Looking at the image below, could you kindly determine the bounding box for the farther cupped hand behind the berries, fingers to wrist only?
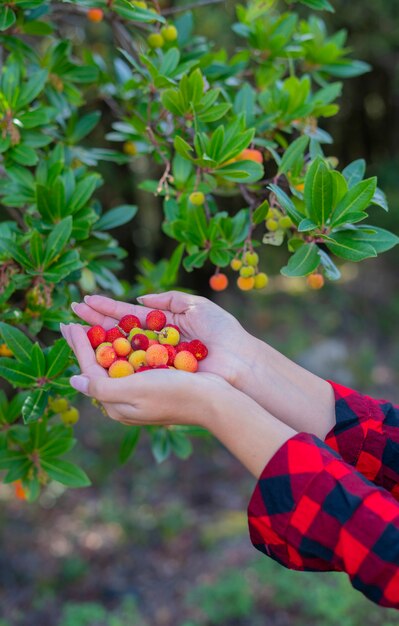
[69,291,254,386]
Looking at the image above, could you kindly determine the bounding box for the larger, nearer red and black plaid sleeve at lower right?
[248,433,399,609]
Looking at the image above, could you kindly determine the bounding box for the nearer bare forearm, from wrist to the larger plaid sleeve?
[203,382,296,478]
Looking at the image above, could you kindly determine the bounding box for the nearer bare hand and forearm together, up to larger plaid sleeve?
[63,324,296,478]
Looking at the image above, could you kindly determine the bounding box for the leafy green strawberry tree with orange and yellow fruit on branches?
[0,0,398,500]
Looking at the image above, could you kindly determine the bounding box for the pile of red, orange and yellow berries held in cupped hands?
[87,311,208,378]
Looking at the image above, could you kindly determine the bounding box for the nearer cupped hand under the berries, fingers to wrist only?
[62,324,229,427]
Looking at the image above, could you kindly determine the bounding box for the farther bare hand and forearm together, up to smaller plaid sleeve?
[68,291,335,439]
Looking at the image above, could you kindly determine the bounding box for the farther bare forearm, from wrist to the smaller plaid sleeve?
[235,334,335,439]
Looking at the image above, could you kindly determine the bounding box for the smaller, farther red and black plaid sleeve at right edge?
[325,381,399,500]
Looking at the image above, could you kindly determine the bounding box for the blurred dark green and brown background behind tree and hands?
[0,0,399,626]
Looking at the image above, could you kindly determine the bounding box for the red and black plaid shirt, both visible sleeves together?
[248,381,399,609]
